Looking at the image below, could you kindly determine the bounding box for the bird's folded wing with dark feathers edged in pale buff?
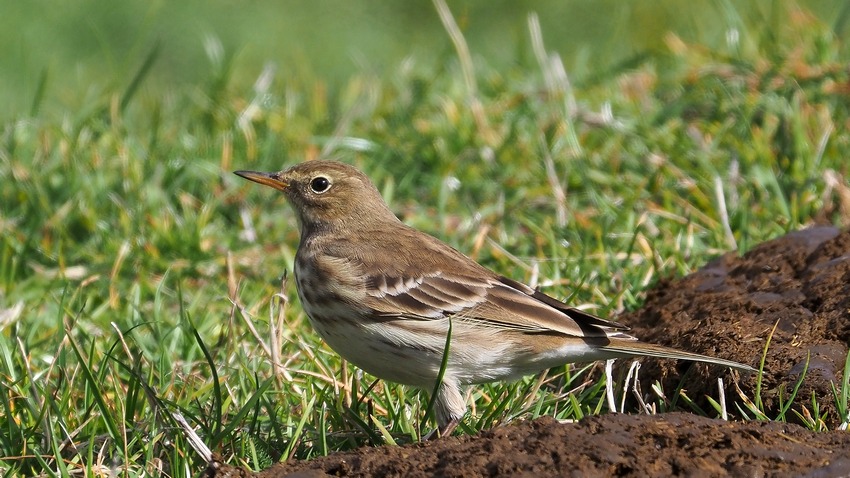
[363,271,631,339]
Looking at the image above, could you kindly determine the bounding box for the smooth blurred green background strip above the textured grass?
[0,0,848,120]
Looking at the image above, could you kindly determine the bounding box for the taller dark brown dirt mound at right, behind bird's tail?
[619,227,850,428]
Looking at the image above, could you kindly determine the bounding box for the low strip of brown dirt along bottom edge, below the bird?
[210,413,850,478]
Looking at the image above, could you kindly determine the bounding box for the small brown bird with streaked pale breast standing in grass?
[235,160,753,436]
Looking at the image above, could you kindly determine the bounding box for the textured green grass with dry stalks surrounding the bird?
[0,0,850,476]
